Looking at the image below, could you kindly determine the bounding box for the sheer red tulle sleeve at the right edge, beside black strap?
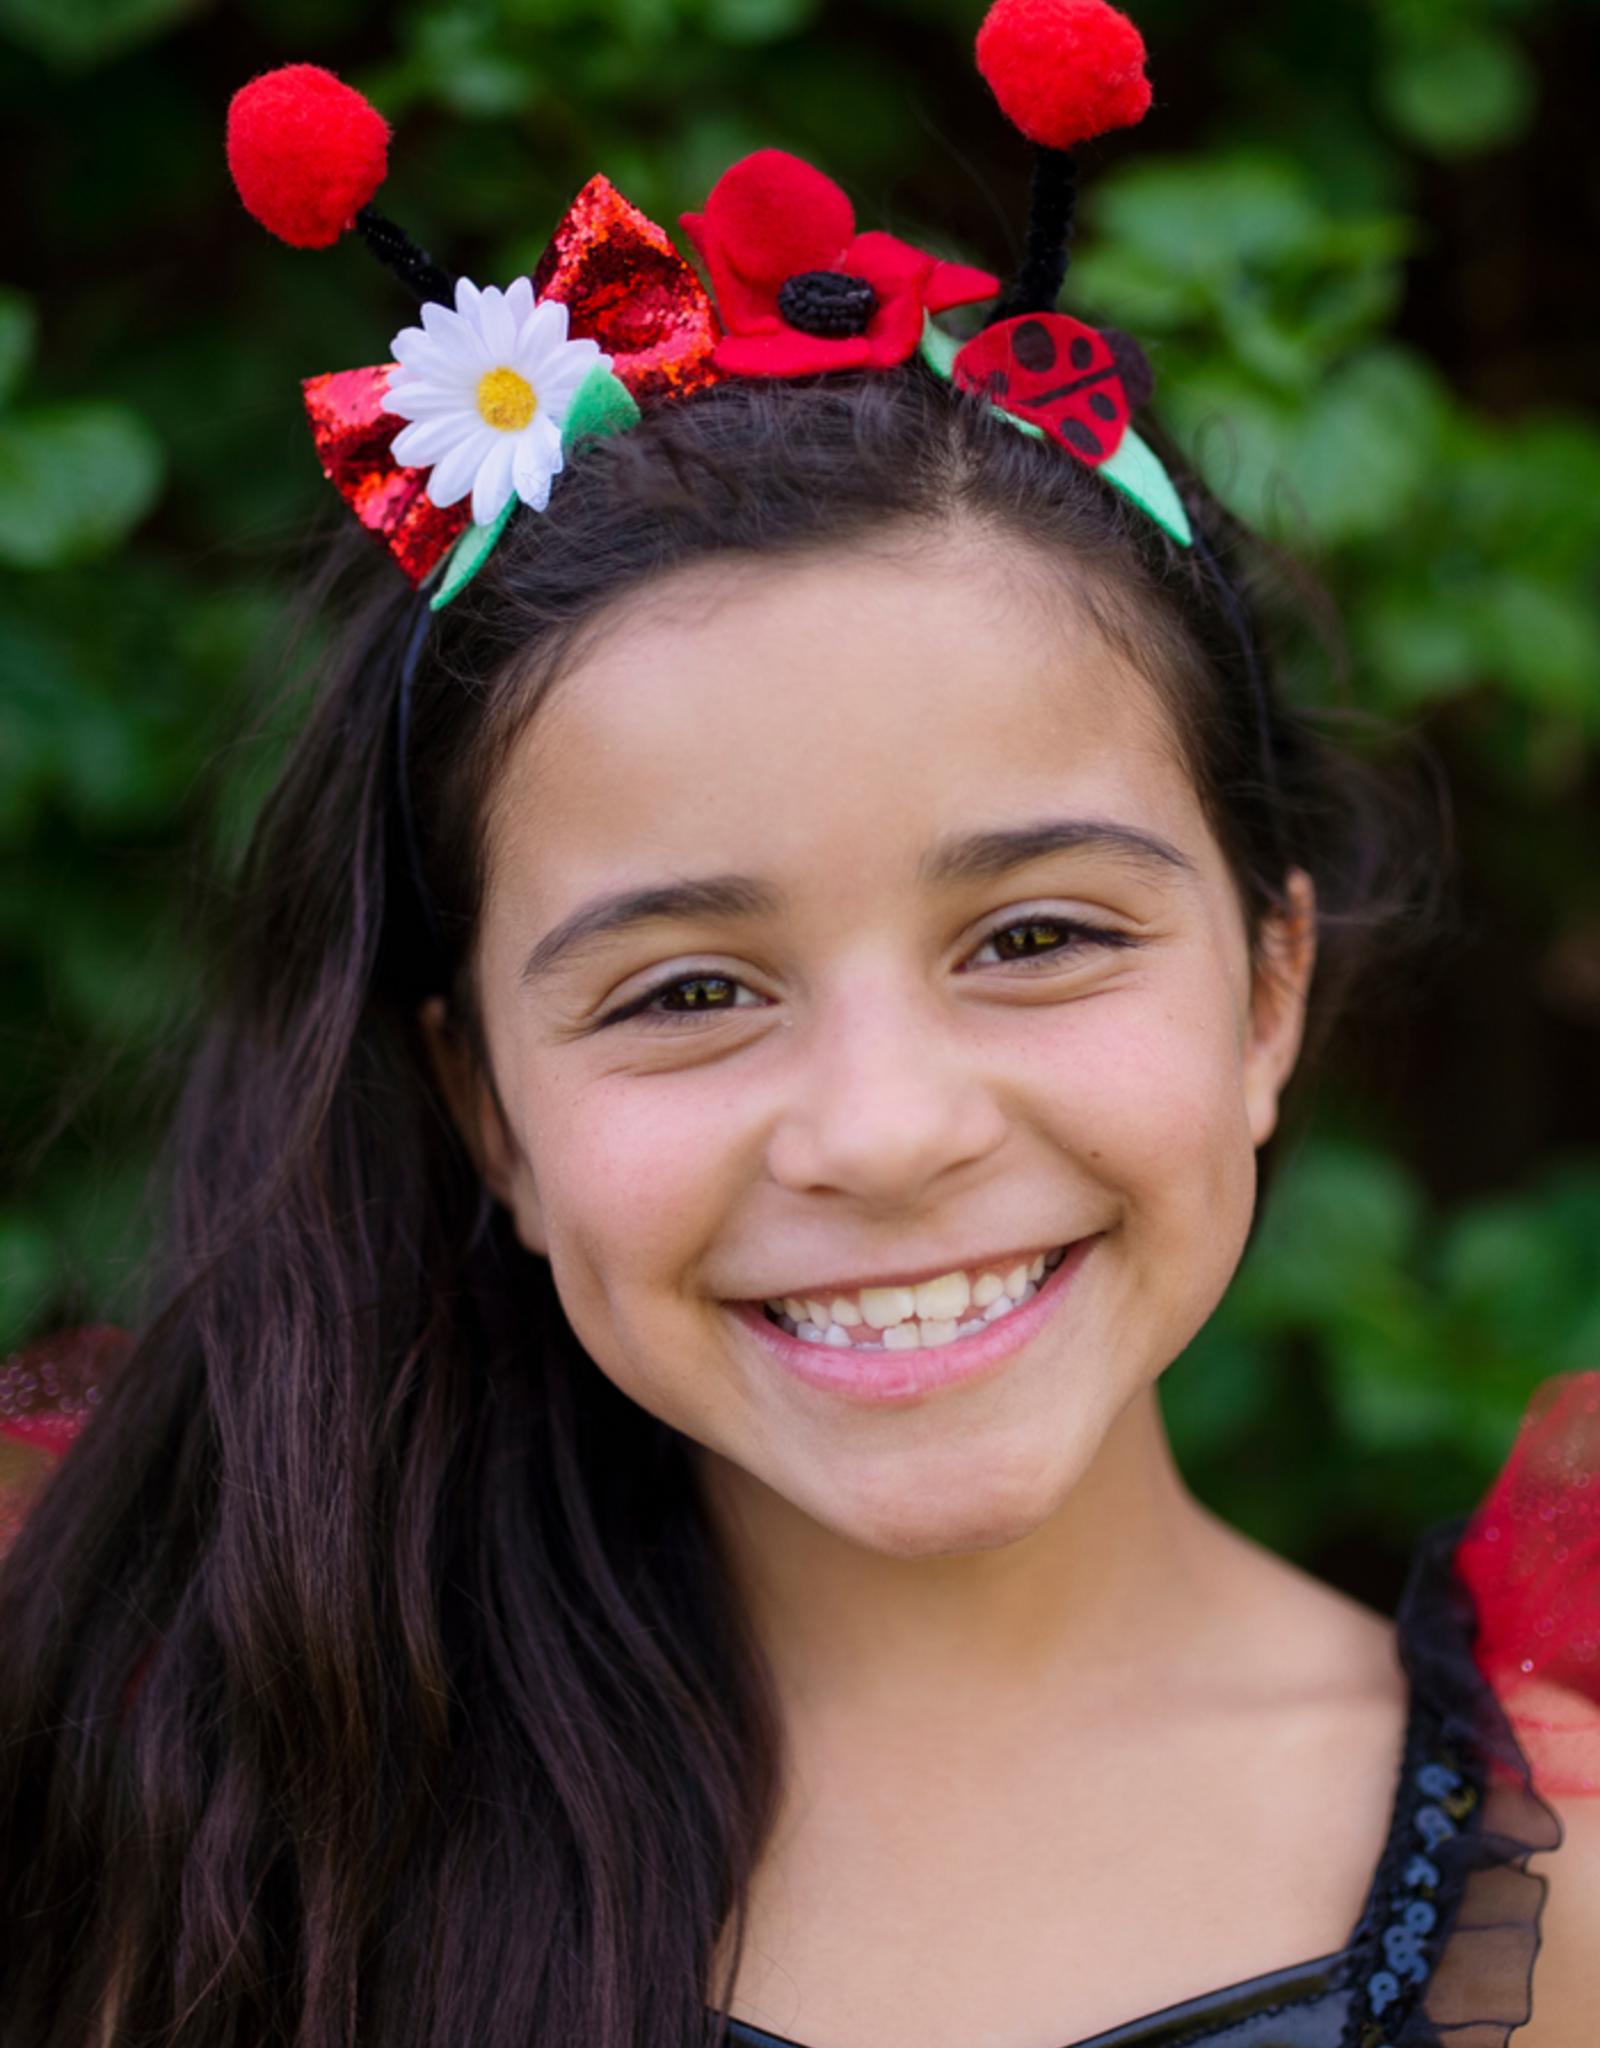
[1457,1372,1600,1798]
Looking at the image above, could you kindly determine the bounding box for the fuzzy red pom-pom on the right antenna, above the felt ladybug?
[977,0,1149,150]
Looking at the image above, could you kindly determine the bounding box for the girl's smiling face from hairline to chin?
[442,532,1309,1556]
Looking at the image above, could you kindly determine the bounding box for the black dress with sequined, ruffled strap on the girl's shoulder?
[727,1528,1559,2048]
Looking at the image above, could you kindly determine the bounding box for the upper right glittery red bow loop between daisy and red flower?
[533,178,721,406]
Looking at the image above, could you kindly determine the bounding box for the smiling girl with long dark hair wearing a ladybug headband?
[0,8,1600,2048]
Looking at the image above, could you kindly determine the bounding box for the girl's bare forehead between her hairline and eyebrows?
[488,535,1203,895]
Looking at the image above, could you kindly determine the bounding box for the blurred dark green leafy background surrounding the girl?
[0,0,1600,1583]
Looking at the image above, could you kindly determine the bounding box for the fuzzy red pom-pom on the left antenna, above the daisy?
[227,63,389,250]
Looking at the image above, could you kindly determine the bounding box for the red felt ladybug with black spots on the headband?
[953,313,1151,469]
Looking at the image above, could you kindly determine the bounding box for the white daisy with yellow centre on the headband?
[383,276,610,526]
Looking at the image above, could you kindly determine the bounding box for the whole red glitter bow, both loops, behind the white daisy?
[305,178,719,584]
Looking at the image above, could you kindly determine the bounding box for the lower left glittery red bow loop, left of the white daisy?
[305,362,471,584]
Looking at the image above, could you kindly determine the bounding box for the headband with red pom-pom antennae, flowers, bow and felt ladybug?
[227,0,1192,610]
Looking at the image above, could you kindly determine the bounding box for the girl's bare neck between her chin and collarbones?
[705,1391,1231,1712]
